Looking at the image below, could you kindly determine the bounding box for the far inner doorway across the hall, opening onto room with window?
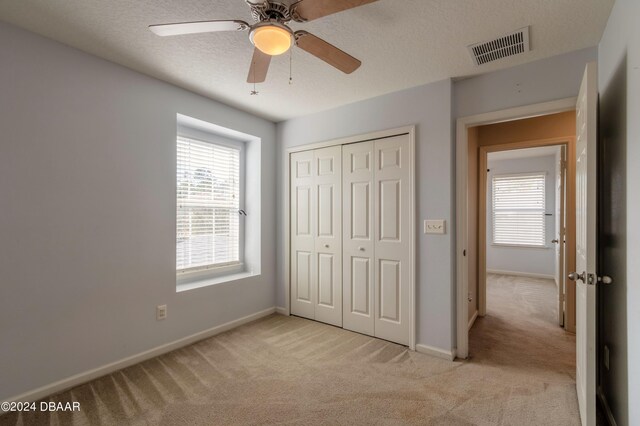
[478,144,567,328]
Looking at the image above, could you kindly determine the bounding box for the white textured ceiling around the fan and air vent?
[0,0,614,121]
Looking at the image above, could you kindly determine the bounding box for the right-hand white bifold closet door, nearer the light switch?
[342,135,413,345]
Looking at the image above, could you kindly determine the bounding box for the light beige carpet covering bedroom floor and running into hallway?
[0,277,579,426]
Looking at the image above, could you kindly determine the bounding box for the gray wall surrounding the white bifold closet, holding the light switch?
[277,80,455,350]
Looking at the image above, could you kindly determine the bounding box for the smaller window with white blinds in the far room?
[492,173,546,247]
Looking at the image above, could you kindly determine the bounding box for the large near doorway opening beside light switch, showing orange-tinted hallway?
[466,111,576,394]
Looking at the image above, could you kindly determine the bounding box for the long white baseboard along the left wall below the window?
[6,307,276,402]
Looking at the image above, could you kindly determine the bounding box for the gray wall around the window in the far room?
[486,154,557,278]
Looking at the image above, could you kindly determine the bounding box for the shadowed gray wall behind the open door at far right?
[598,0,640,425]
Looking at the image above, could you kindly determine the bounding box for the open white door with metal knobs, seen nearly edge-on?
[571,63,598,426]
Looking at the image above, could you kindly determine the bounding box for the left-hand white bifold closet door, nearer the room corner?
[290,146,342,326]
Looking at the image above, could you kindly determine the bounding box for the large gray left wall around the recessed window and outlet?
[0,23,276,400]
